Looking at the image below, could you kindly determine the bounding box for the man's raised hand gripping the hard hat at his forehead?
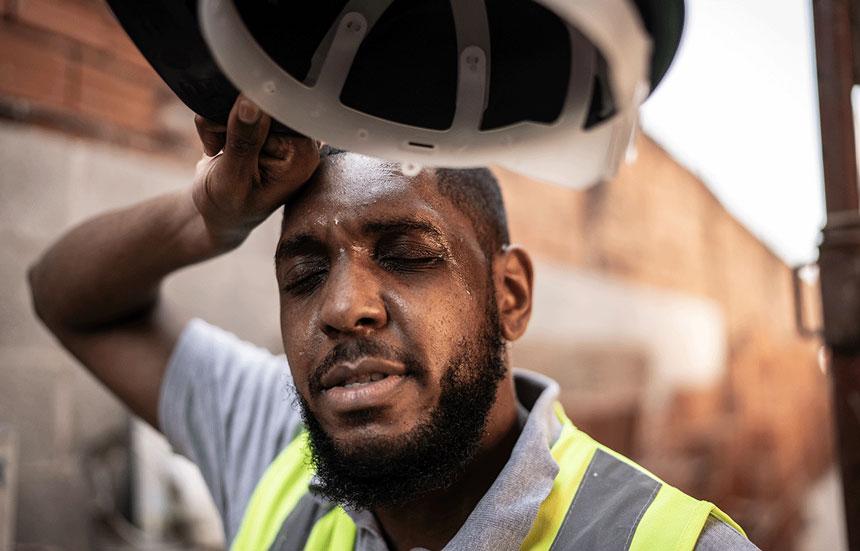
[192,95,319,248]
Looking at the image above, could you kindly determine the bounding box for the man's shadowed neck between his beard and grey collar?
[374,376,521,551]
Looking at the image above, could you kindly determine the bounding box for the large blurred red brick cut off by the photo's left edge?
[0,22,69,109]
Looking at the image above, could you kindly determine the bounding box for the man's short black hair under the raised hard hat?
[320,145,511,259]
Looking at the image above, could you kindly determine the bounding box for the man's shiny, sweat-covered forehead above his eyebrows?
[282,153,466,242]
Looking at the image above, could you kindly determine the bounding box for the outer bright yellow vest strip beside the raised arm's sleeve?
[230,432,313,551]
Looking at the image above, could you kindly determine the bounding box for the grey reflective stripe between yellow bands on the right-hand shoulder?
[551,449,662,551]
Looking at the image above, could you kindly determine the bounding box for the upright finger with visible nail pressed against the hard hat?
[223,95,270,178]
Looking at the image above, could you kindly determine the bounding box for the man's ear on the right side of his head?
[493,245,534,341]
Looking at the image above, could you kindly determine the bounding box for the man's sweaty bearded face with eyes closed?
[276,154,504,506]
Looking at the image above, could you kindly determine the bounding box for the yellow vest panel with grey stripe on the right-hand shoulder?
[521,404,743,551]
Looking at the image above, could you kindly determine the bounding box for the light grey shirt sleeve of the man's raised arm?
[158,319,301,541]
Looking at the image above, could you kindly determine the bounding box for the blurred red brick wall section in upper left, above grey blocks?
[0,0,197,160]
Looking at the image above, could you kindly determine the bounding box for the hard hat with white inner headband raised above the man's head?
[110,0,684,187]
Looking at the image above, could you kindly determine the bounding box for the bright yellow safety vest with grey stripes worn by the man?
[231,403,744,551]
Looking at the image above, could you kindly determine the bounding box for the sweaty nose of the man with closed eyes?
[320,260,388,338]
